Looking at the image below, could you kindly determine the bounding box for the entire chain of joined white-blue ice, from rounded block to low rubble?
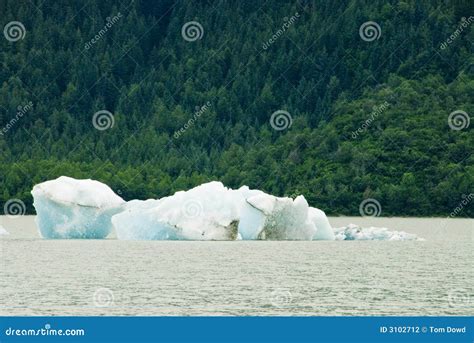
[30,176,420,241]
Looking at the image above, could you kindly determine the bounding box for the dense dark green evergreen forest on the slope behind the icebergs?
[0,0,474,216]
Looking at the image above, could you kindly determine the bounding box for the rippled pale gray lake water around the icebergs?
[0,216,474,316]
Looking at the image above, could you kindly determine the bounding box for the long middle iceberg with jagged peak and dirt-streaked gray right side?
[112,181,334,240]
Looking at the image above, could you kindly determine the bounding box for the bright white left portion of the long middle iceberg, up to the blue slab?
[112,182,243,240]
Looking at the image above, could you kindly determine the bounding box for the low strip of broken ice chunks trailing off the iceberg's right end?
[334,224,423,241]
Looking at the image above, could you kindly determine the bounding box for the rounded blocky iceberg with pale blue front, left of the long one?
[31,176,125,239]
